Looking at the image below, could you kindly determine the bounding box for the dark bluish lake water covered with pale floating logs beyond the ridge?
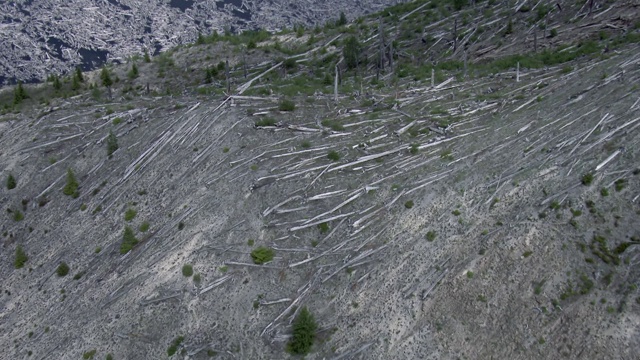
[0,0,395,85]
